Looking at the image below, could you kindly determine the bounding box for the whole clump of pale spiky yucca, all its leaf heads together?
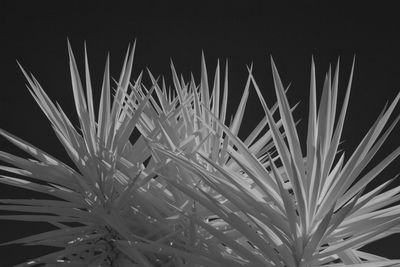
[0,42,400,266]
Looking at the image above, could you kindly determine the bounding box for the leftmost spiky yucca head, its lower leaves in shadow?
[0,44,222,266]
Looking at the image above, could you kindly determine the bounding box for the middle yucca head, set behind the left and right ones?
[138,55,288,218]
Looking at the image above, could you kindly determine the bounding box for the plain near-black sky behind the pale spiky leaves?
[0,1,400,266]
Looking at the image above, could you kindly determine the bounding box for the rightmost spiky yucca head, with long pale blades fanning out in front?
[154,58,400,266]
